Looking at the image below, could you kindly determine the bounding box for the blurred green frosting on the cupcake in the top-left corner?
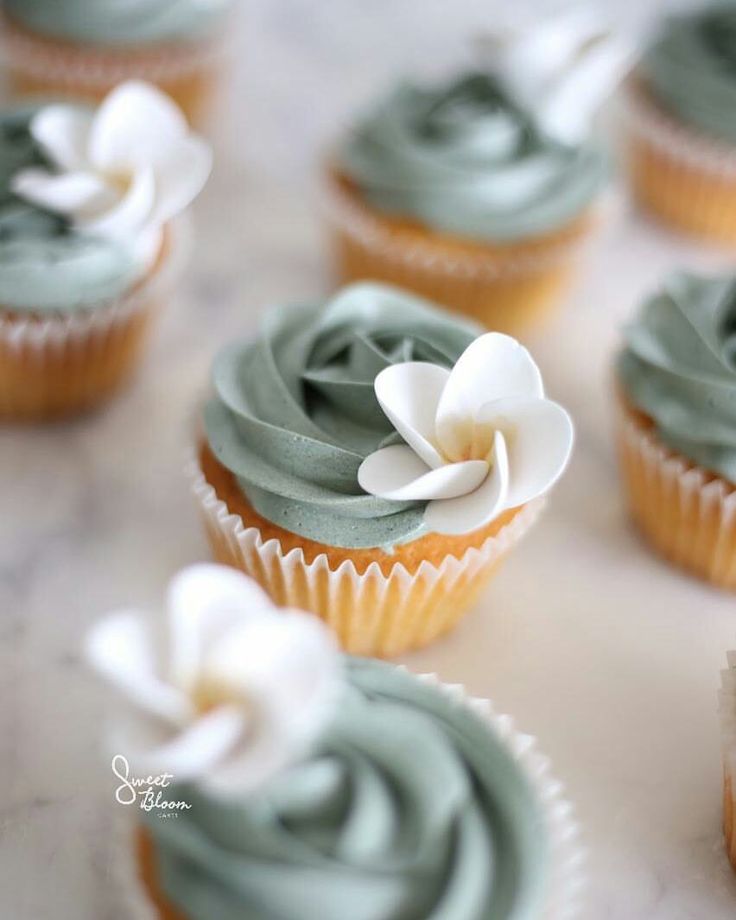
[3,0,233,45]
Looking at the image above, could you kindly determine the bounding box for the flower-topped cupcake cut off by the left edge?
[0,83,211,420]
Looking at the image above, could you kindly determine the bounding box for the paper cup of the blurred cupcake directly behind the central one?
[323,177,600,335]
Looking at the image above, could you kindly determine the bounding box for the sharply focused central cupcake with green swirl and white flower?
[192,283,572,657]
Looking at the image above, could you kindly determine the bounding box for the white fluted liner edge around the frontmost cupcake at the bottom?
[113,667,586,920]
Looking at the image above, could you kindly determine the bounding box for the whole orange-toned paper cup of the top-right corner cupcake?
[625,83,736,246]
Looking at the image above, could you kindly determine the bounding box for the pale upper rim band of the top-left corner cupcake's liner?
[0,13,225,87]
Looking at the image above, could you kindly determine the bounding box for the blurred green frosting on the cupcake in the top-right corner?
[641,2,736,143]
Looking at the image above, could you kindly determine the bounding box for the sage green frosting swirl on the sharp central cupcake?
[205,283,481,550]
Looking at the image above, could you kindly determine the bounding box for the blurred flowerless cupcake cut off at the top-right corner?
[628,2,736,245]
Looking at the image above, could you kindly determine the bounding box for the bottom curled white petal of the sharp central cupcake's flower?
[424,432,509,534]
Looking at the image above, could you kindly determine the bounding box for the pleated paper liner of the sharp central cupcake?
[187,459,544,658]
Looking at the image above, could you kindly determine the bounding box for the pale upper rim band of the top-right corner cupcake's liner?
[623,80,736,180]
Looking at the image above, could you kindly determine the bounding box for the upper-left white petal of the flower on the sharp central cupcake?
[373,361,450,469]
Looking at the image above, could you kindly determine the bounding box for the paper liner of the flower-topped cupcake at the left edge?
[0,219,190,421]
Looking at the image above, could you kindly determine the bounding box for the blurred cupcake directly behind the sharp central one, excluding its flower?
[327,72,606,334]
